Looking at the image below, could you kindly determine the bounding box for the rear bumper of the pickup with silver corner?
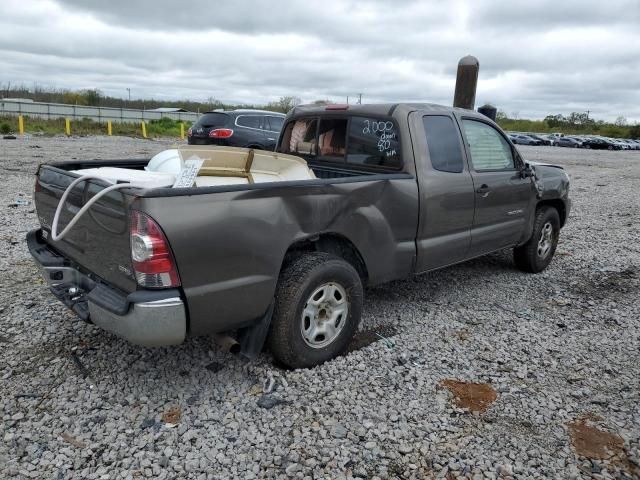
[27,230,187,347]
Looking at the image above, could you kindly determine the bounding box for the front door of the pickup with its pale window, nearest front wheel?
[462,117,534,257]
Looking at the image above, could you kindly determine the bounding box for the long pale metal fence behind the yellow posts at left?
[0,100,199,123]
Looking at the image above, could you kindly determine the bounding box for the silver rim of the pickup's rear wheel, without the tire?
[300,282,349,348]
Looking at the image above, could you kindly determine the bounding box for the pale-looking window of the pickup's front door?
[462,120,515,172]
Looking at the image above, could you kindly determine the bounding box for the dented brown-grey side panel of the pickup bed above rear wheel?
[140,174,418,335]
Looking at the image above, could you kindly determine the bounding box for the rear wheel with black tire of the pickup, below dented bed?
[267,252,363,368]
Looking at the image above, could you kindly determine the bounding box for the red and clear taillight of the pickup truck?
[131,210,180,288]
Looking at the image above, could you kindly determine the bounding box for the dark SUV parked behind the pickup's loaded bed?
[187,110,285,150]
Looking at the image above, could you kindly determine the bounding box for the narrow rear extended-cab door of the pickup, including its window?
[410,112,475,272]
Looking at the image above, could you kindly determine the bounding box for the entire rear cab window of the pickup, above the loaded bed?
[277,116,402,170]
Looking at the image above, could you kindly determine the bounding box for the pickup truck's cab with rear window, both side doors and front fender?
[276,104,569,273]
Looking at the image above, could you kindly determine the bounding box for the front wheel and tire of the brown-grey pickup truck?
[513,206,560,273]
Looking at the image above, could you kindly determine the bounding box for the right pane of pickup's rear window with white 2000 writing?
[347,117,402,169]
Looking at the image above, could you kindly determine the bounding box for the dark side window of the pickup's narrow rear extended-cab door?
[422,115,463,173]
